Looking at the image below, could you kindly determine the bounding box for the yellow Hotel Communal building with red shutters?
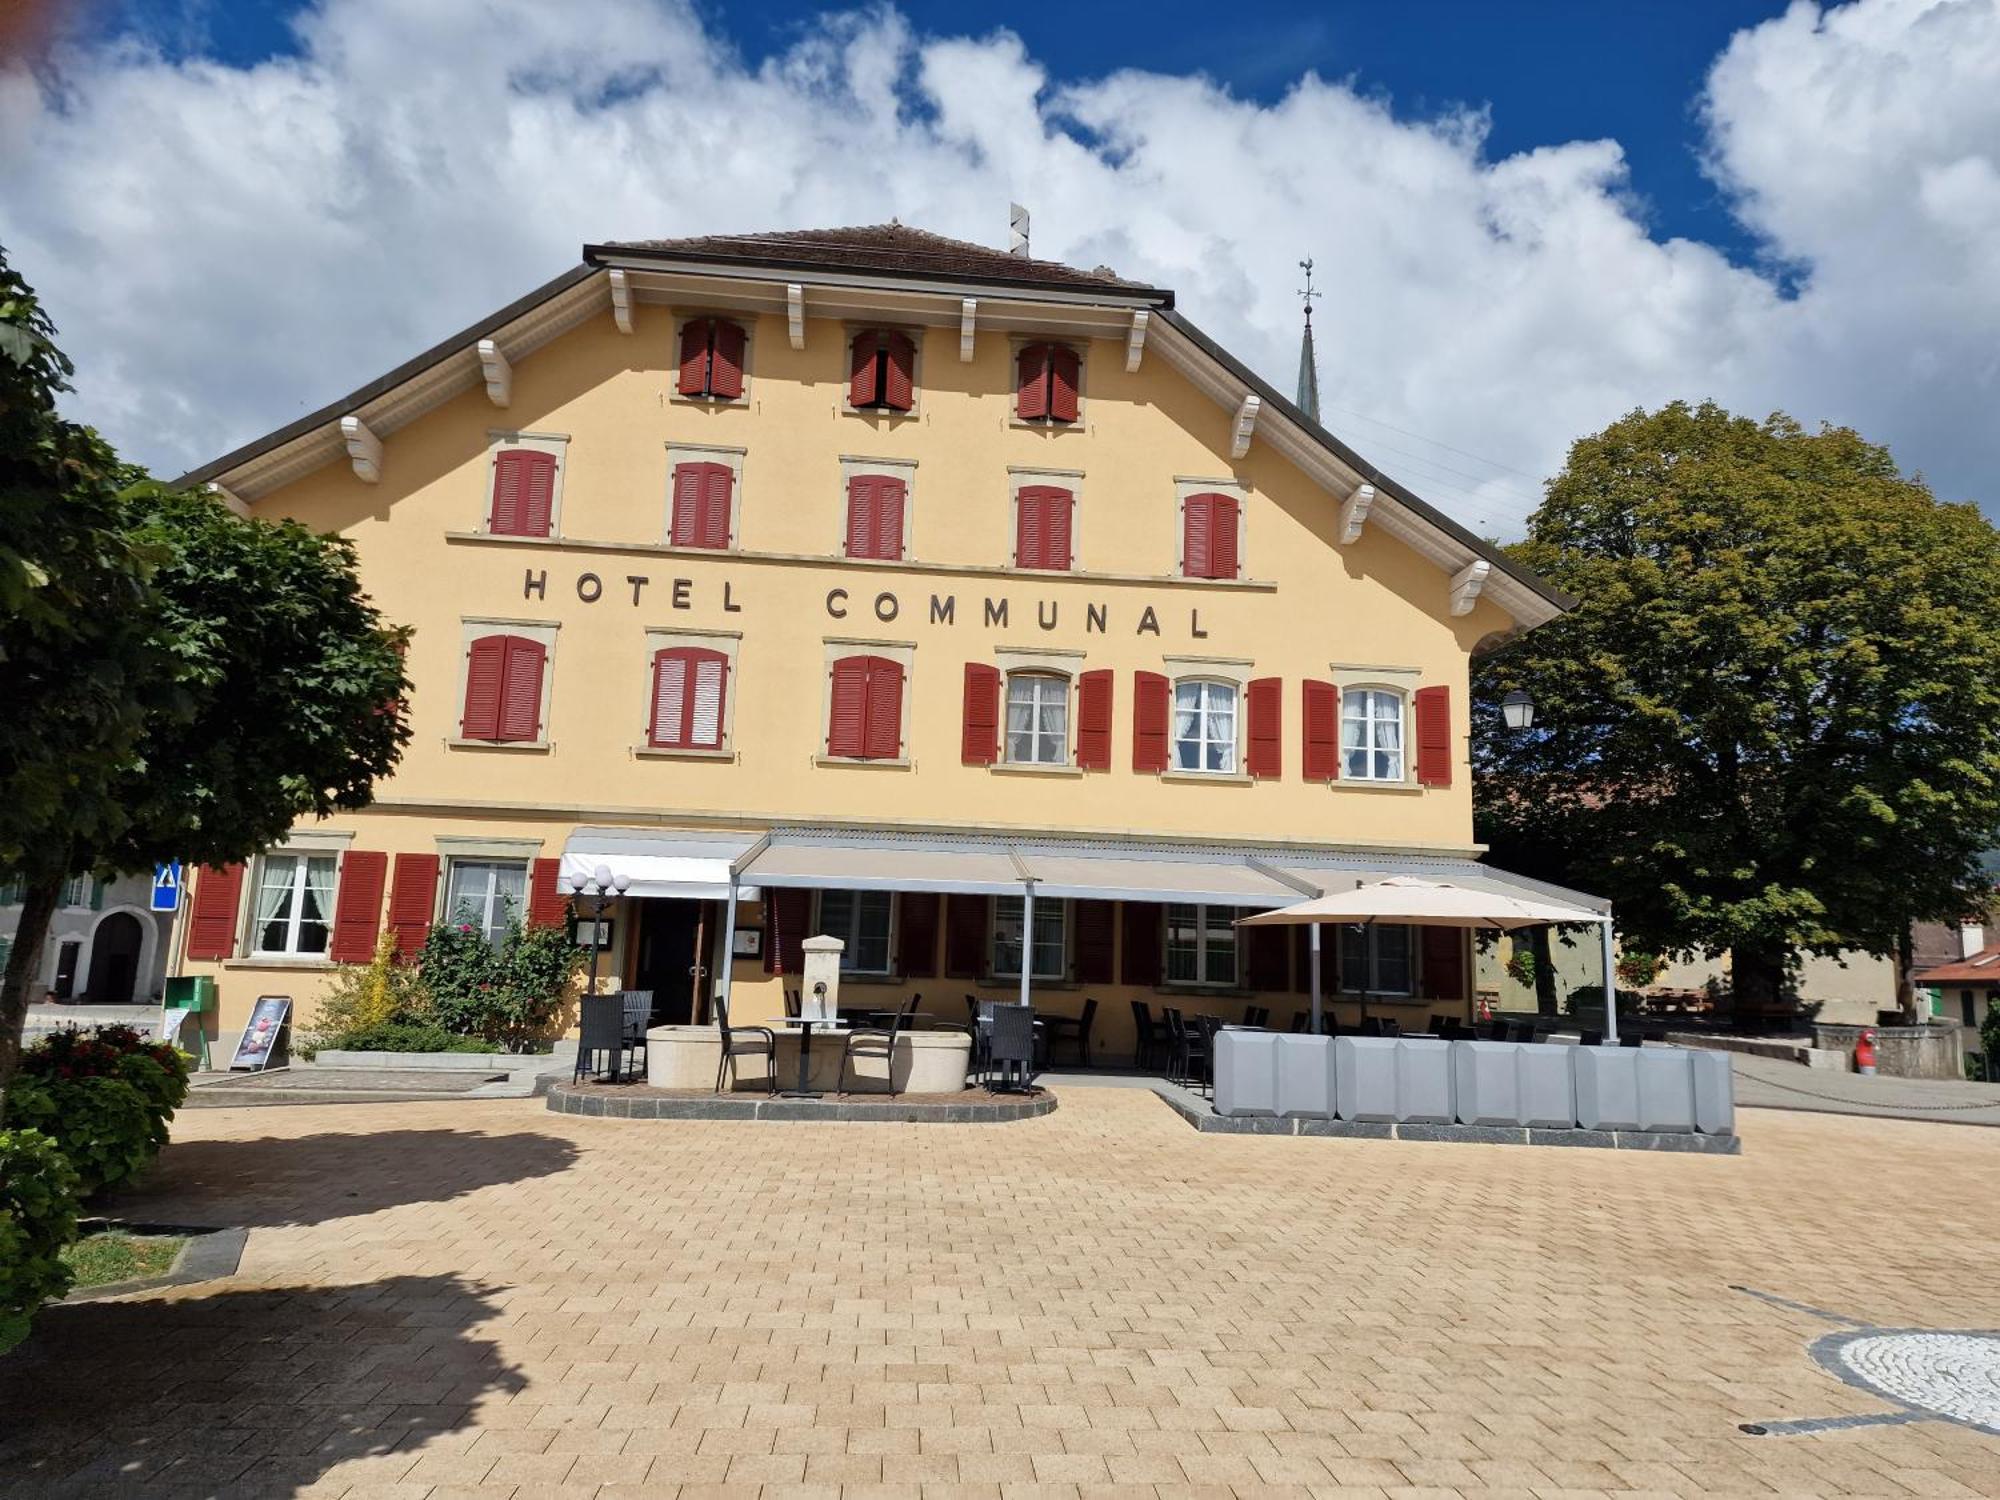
[184,226,1600,1060]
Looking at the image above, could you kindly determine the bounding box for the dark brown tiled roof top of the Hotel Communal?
[590,224,1154,292]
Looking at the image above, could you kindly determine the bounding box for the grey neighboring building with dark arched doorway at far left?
[0,874,174,1006]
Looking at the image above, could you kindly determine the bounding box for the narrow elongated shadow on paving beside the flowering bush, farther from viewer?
[92,1130,576,1228]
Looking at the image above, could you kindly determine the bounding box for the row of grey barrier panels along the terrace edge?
[1214,1028,1736,1136]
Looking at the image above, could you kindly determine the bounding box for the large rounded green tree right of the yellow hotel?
[1474,402,2000,1012]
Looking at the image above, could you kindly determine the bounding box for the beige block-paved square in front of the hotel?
[0,1088,2000,1500]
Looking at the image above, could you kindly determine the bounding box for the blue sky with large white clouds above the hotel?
[0,0,2000,538]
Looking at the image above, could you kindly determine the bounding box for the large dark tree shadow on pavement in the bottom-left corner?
[0,1276,526,1500]
